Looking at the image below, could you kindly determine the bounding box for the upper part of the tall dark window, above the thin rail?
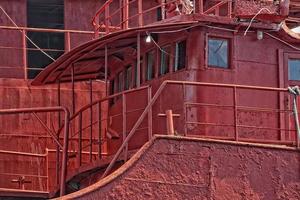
[27,0,64,29]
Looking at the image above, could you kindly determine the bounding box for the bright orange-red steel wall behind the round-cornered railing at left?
[0,79,104,191]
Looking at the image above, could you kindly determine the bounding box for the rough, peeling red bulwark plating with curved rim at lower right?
[63,138,300,200]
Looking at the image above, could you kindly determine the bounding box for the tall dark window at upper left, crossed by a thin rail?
[27,0,65,79]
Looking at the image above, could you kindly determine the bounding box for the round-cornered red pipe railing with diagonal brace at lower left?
[0,106,70,196]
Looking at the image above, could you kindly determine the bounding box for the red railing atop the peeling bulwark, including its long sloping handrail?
[102,80,299,177]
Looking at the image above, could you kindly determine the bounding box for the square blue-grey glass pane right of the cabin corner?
[208,38,229,68]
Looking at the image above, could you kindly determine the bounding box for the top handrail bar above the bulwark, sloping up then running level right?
[101,80,290,178]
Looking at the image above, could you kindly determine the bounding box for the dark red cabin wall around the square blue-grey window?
[109,26,300,151]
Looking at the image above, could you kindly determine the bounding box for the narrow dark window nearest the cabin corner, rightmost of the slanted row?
[174,40,186,71]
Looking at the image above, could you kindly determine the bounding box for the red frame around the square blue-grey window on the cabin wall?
[204,33,235,71]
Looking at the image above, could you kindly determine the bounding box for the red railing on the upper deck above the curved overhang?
[92,0,232,37]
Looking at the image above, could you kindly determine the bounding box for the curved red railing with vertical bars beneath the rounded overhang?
[65,86,151,167]
